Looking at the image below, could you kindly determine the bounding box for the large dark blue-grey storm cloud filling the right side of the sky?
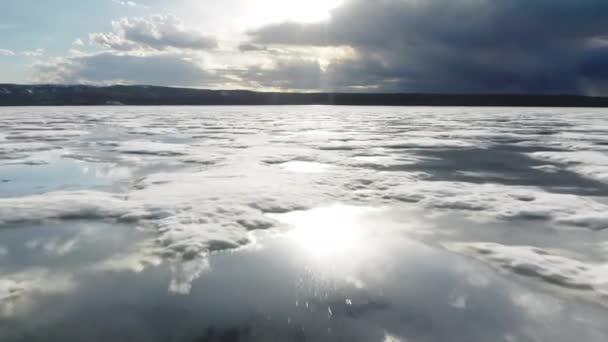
[249,0,608,93]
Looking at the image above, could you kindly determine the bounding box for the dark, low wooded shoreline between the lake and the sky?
[0,84,608,108]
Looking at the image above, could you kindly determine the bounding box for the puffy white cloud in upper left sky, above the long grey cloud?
[89,15,218,51]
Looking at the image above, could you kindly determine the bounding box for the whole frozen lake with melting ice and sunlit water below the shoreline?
[0,106,608,342]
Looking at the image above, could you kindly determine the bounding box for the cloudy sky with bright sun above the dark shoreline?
[0,0,608,96]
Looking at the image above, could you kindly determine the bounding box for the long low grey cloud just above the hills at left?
[36,53,221,86]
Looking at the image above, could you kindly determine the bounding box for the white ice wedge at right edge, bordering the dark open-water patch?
[529,151,608,183]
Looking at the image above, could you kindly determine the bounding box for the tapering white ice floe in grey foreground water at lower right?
[445,242,608,299]
